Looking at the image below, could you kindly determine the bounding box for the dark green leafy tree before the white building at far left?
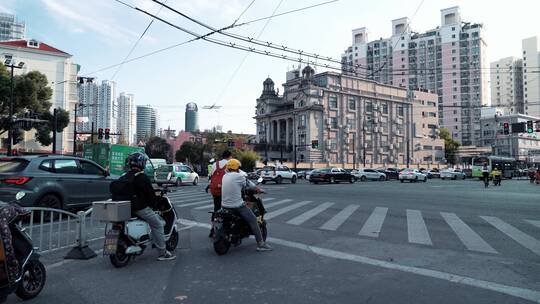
[0,64,69,146]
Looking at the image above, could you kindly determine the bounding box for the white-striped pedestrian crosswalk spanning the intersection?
[169,190,540,256]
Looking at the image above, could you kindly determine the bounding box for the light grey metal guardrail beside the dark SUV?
[19,207,103,259]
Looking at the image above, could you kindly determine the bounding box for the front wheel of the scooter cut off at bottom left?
[15,260,47,300]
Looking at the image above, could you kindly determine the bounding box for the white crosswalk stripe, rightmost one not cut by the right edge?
[441,212,498,253]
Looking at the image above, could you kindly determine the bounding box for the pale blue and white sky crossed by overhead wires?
[0,0,540,134]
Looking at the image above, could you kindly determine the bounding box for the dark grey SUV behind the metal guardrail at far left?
[0,155,118,209]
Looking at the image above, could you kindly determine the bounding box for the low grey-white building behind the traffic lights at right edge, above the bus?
[481,109,540,161]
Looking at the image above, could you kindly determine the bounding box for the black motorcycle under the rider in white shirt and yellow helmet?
[210,178,268,255]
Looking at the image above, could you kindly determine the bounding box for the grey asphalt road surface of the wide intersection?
[10,180,540,303]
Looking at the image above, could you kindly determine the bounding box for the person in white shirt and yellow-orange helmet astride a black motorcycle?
[221,158,272,251]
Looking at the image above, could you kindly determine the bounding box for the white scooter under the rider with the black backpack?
[103,187,178,268]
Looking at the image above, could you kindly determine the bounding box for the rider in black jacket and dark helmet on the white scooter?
[121,152,176,261]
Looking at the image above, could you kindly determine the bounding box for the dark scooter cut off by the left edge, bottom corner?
[0,191,46,303]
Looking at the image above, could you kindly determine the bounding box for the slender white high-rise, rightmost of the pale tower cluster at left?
[117,93,137,145]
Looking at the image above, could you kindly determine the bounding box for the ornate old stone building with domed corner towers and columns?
[255,66,444,164]
